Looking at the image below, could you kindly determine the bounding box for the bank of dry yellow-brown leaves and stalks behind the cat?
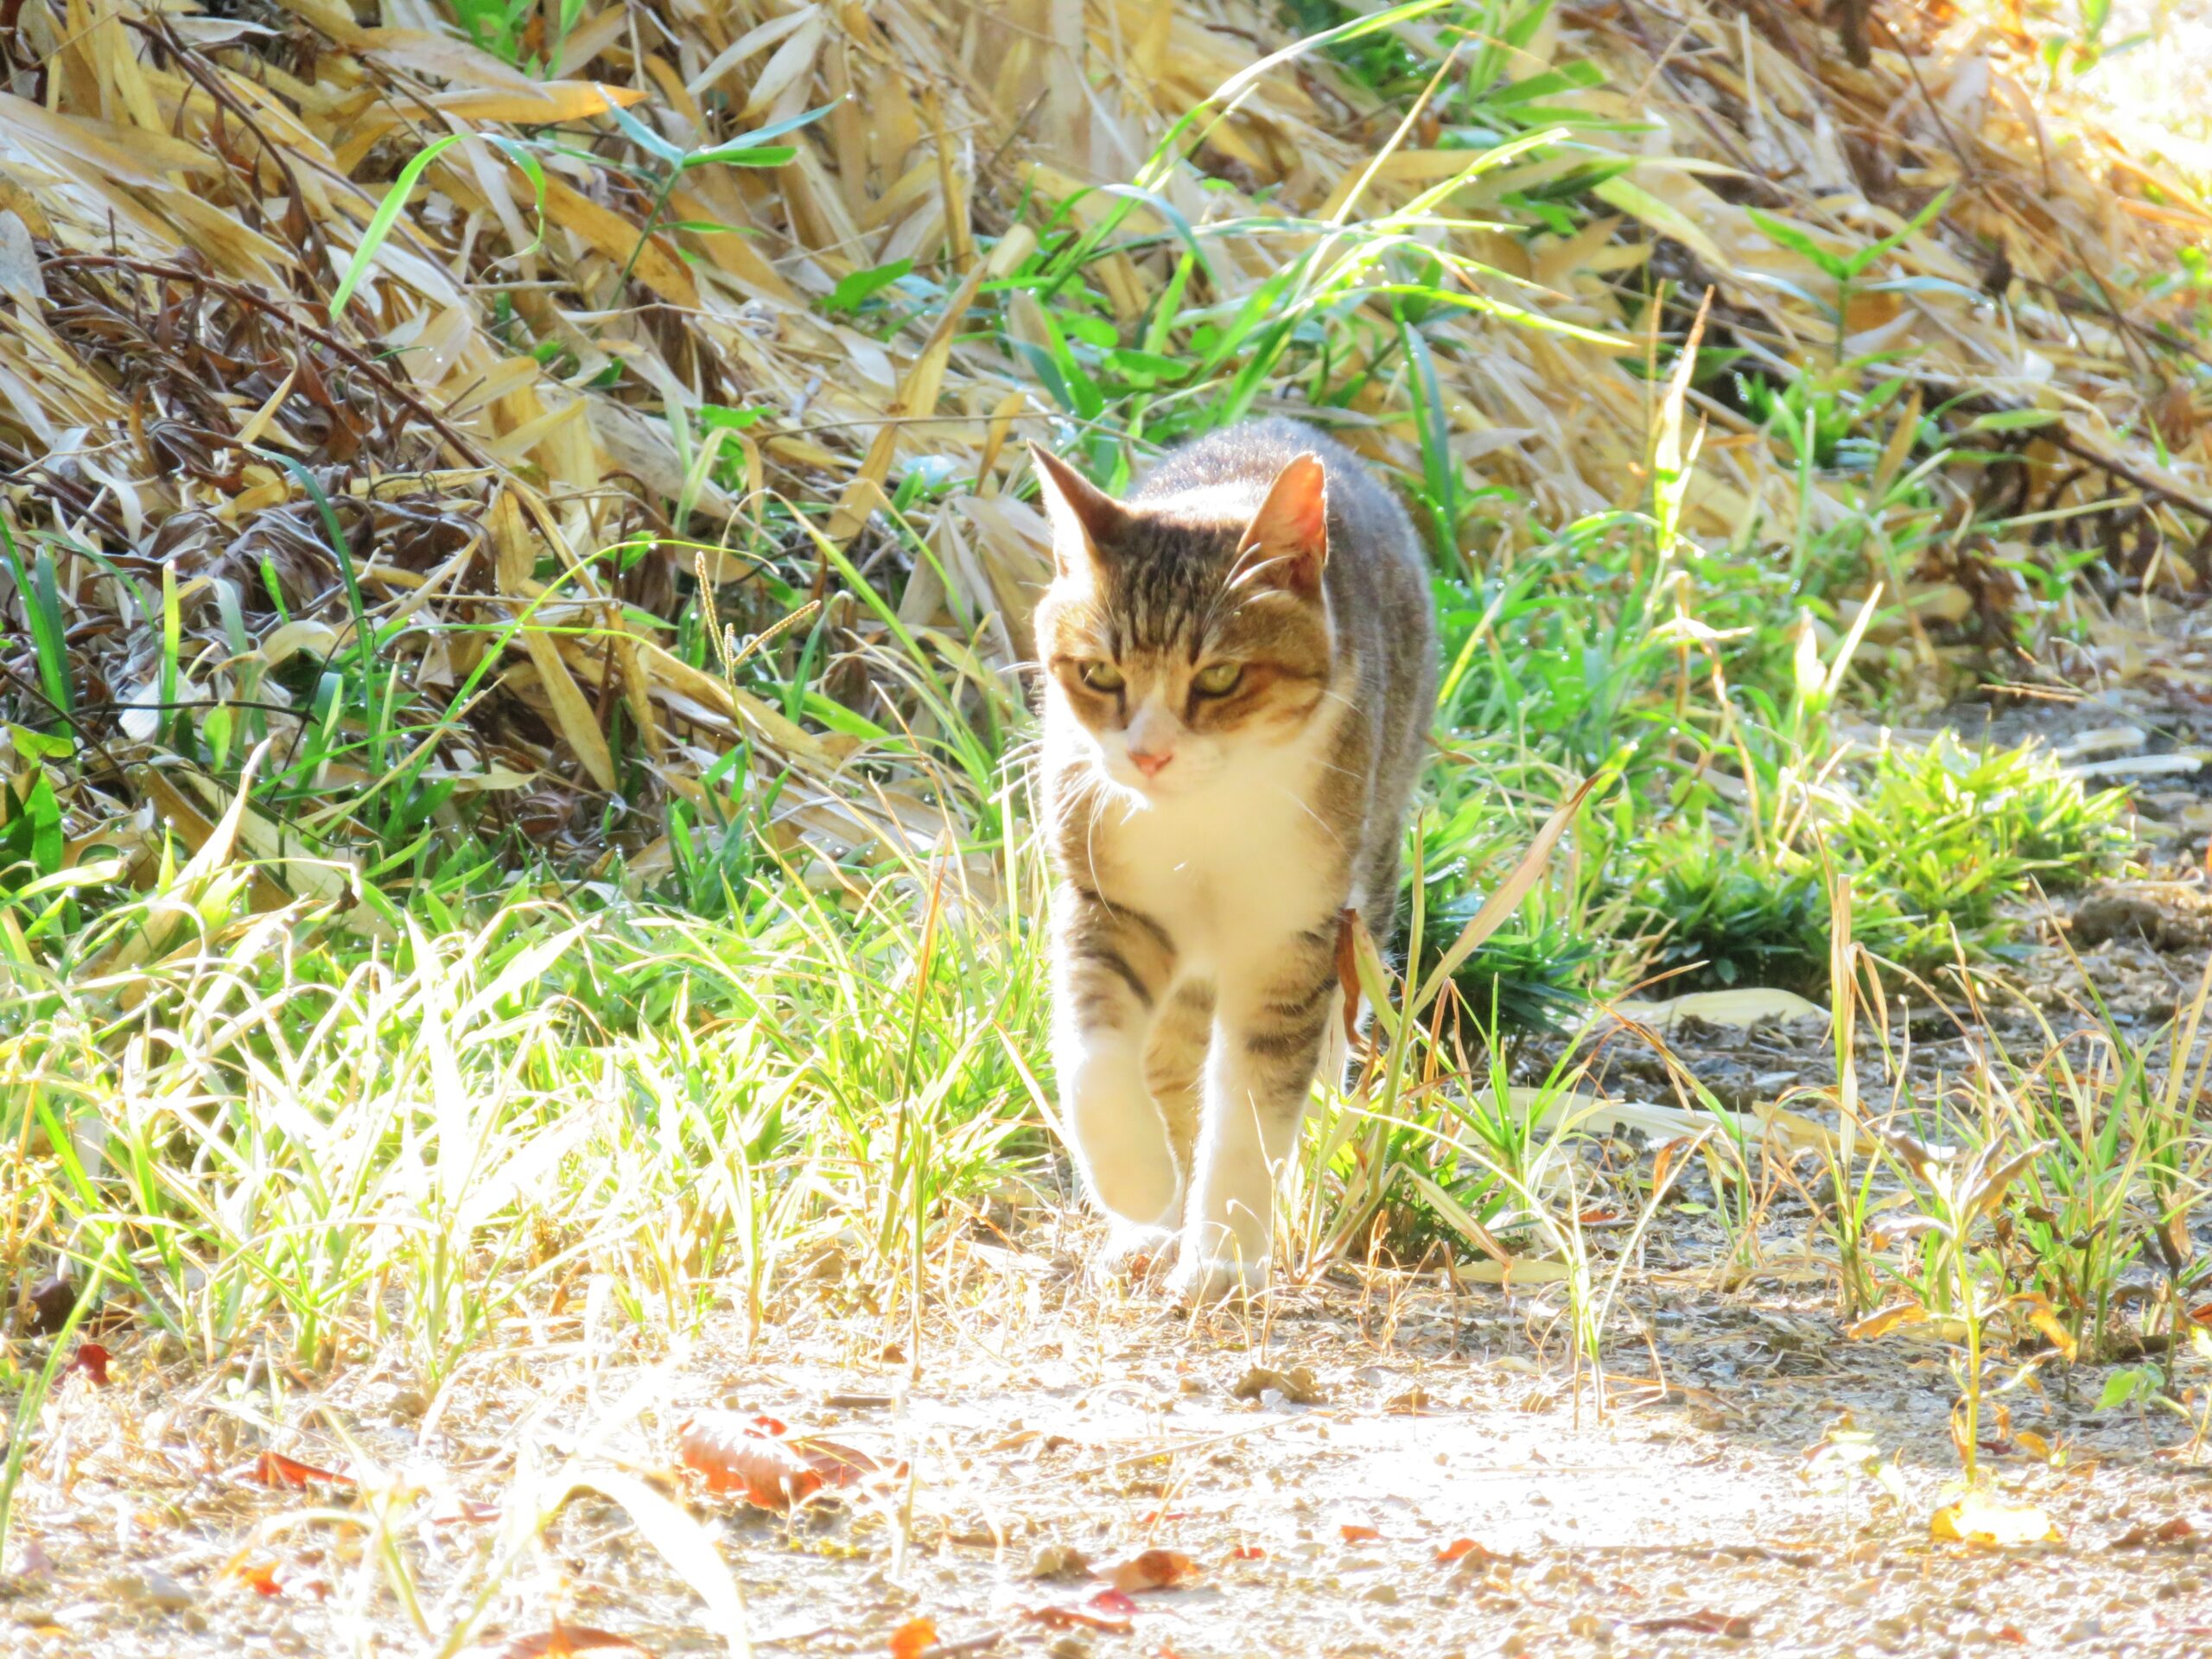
[0,0,2212,885]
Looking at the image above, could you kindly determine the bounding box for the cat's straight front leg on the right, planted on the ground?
[1173,923,1343,1303]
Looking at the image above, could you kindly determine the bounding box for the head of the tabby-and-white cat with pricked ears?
[1033,449,1334,798]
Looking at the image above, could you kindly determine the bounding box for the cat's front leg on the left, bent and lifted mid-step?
[1053,882,1181,1265]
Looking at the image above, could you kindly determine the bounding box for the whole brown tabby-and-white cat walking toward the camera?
[1031,420,1435,1303]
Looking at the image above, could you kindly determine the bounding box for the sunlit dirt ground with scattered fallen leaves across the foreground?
[0,1248,2212,1659]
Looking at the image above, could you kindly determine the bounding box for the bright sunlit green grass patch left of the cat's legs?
[0,800,1048,1380]
